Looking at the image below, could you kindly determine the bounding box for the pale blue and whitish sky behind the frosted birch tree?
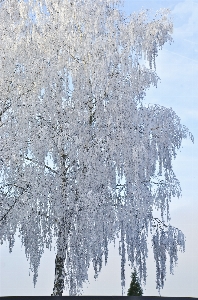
[0,0,198,297]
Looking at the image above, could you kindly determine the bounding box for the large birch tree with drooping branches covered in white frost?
[0,0,191,295]
